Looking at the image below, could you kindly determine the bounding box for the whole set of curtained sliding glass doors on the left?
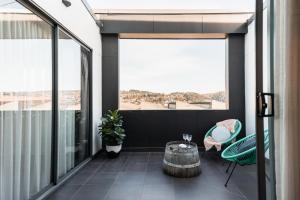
[0,1,90,200]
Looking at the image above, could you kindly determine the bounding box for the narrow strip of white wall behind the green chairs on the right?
[245,21,256,135]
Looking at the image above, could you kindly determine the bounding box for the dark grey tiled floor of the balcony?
[48,152,257,200]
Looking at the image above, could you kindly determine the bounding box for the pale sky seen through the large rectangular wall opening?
[119,39,226,93]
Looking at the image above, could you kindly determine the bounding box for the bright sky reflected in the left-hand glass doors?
[0,39,81,92]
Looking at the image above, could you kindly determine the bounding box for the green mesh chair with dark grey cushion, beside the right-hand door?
[221,130,269,187]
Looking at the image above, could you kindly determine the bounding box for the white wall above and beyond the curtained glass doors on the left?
[32,0,102,154]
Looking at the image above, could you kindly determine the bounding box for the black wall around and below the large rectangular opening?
[102,34,245,149]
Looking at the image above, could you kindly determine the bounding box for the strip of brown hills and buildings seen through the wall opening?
[119,90,227,110]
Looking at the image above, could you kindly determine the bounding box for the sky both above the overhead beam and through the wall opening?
[88,0,255,93]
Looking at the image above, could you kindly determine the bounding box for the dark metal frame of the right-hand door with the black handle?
[255,0,276,200]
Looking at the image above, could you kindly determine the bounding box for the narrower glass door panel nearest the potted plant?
[58,30,89,178]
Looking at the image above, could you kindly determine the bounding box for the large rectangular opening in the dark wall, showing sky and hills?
[119,39,228,110]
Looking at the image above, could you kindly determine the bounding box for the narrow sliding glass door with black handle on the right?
[256,0,278,200]
